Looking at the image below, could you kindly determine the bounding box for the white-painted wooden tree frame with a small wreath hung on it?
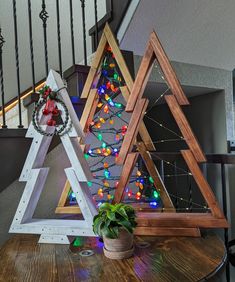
[9,70,97,244]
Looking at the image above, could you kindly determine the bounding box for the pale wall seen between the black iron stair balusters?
[0,0,106,102]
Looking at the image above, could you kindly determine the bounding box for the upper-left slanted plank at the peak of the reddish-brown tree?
[125,42,154,112]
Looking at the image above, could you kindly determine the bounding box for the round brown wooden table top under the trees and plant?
[0,234,226,282]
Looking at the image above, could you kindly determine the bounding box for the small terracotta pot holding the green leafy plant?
[103,229,134,259]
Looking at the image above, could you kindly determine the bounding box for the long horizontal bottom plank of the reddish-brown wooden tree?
[137,212,229,228]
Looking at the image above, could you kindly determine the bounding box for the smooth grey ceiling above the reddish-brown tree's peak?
[121,0,235,70]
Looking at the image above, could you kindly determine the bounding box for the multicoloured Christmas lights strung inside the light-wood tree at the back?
[81,47,162,205]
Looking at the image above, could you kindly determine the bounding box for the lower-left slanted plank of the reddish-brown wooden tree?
[113,153,139,203]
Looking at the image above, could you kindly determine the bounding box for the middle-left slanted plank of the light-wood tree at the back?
[80,88,99,132]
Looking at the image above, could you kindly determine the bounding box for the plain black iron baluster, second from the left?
[12,0,24,128]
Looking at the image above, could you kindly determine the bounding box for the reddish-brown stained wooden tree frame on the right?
[114,29,228,236]
